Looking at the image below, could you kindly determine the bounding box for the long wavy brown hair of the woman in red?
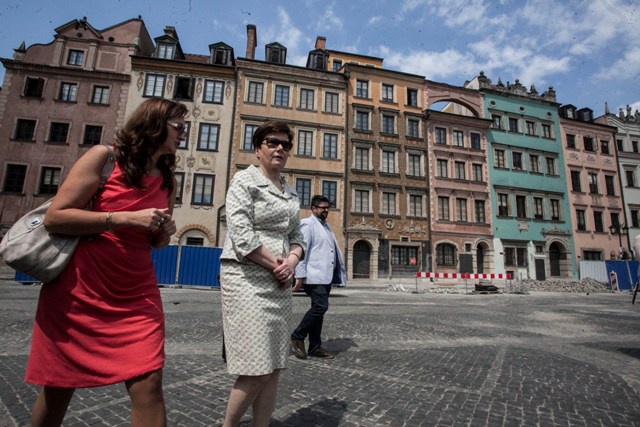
[114,98,188,192]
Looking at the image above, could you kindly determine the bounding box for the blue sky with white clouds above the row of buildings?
[0,0,640,116]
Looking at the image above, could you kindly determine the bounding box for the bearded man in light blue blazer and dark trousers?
[291,196,346,359]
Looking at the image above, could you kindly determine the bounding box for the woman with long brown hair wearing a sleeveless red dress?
[25,98,187,426]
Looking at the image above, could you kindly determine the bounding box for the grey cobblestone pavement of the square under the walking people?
[0,282,640,427]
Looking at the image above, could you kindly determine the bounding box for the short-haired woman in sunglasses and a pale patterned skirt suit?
[220,122,305,427]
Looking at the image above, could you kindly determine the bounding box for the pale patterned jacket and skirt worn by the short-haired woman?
[220,166,306,376]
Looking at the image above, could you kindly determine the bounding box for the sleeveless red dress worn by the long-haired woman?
[25,162,168,388]
